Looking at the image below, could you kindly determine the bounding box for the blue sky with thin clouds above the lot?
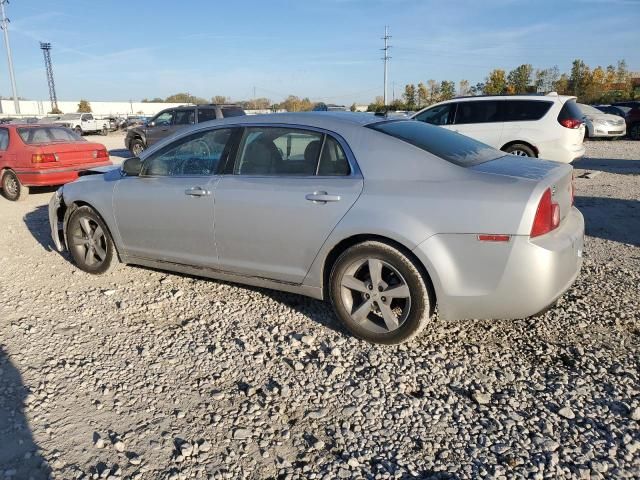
[0,0,640,105]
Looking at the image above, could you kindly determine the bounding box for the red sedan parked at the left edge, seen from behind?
[0,125,111,200]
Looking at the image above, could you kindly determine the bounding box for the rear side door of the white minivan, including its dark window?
[451,100,504,149]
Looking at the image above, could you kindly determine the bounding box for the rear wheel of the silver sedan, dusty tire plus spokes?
[329,241,434,345]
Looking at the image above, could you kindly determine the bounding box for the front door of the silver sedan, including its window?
[113,128,240,267]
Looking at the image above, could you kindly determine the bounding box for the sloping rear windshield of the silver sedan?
[369,120,505,167]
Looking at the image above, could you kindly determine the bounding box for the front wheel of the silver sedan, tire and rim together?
[65,206,119,275]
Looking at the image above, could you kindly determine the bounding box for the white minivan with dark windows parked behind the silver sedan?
[412,92,585,163]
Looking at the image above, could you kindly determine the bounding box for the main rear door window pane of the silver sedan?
[235,127,322,176]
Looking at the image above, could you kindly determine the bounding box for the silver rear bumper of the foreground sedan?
[414,208,584,319]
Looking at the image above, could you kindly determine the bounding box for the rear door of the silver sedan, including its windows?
[215,126,363,283]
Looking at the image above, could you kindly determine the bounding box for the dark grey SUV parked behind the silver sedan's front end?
[124,103,245,157]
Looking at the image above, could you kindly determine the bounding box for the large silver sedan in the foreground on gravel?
[49,112,584,343]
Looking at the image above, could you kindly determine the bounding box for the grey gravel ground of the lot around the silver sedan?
[0,135,640,479]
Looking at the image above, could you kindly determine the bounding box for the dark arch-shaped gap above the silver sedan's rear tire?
[322,233,437,307]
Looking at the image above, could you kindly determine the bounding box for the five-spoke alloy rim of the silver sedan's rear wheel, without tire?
[340,258,411,333]
